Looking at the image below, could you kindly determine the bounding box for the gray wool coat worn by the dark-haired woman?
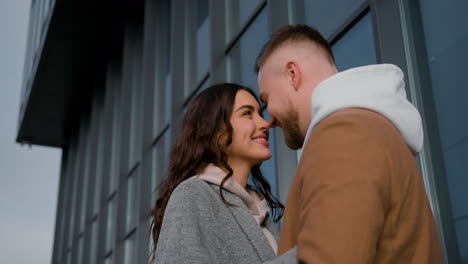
[154,178,296,264]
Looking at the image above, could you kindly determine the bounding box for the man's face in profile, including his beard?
[258,69,304,149]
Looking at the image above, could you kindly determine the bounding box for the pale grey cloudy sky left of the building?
[0,0,62,264]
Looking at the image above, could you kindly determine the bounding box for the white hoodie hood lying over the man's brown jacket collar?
[304,64,423,154]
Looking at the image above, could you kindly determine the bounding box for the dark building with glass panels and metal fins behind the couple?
[17,0,468,264]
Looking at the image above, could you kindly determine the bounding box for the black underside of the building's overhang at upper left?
[16,0,130,147]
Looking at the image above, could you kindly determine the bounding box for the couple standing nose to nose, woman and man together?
[151,25,442,263]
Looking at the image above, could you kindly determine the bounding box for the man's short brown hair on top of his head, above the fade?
[255,24,335,73]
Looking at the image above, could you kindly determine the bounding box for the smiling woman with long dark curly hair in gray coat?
[151,84,295,263]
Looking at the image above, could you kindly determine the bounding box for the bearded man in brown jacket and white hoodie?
[256,25,443,263]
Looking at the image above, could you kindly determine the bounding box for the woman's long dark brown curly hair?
[151,83,284,259]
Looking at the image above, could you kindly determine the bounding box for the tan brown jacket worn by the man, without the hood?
[278,108,443,264]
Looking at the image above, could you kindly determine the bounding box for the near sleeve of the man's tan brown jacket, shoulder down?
[296,115,390,263]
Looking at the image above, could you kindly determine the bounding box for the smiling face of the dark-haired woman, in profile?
[226,90,271,166]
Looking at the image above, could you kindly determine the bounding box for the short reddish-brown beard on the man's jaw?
[280,104,304,149]
